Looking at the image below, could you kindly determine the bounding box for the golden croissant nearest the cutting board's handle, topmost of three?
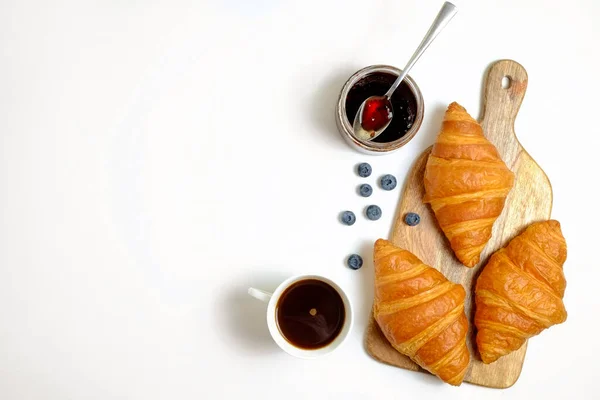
[423,103,514,267]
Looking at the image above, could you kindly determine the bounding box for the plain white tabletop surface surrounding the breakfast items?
[0,0,600,400]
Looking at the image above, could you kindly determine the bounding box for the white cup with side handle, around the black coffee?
[248,275,354,358]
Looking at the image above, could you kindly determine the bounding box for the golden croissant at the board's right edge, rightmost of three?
[475,220,567,364]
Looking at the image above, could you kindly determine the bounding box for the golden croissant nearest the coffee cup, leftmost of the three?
[374,239,470,385]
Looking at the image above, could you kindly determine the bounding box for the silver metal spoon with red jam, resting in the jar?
[352,2,458,141]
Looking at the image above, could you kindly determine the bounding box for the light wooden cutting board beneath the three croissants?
[366,60,552,388]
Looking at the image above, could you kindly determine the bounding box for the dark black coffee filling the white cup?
[277,279,346,349]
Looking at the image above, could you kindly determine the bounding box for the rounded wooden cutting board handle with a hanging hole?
[481,60,527,132]
